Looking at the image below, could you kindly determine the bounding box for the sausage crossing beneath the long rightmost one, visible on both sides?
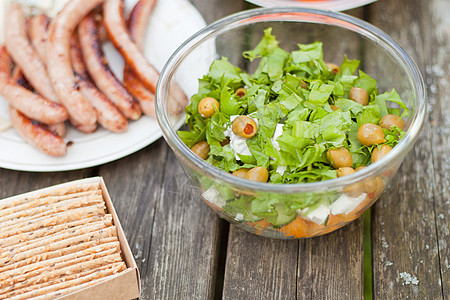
[123,0,156,116]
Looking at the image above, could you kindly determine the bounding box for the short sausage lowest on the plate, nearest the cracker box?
[9,105,67,156]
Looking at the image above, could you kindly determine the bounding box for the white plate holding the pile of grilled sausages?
[0,0,208,172]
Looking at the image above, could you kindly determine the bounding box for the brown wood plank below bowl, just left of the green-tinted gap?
[297,218,364,299]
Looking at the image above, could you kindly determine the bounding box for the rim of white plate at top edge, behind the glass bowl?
[247,0,376,11]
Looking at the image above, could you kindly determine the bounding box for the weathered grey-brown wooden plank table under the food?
[0,0,450,299]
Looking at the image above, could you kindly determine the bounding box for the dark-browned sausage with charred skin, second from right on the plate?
[78,14,142,120]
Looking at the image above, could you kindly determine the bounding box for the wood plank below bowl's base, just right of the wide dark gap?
[222,226,299,300]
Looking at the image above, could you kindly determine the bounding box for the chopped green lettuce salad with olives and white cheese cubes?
[178,28,408,184]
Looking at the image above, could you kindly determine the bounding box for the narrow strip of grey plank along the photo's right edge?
[421,0,450,298]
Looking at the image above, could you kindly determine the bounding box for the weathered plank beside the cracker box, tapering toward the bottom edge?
[99,139,168,299]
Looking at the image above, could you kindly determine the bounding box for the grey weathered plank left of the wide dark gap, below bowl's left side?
[143,151,221,299]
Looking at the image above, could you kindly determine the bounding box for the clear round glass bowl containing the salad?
[156,8,426,239]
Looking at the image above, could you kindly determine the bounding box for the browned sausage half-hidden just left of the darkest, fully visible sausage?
[70,37,128,132]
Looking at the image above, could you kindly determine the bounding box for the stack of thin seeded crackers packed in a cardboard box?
[0,183,127,299]
